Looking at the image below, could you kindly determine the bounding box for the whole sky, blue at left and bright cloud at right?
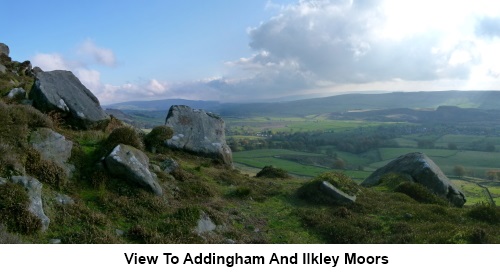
[0,0,500,104]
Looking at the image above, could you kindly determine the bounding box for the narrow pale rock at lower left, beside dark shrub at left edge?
[10,176,50,231]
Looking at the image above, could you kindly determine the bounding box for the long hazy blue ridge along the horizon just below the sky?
[101,91,500,117]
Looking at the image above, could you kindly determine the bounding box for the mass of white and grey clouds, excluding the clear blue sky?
[30,0,500,102]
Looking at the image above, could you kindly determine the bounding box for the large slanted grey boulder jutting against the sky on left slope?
[29,70,109,128]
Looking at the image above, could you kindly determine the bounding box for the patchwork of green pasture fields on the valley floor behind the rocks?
[228,116,500,205]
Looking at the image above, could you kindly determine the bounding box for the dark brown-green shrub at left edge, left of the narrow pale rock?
[0,183,42,234]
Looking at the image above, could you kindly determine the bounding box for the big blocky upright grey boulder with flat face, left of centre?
[165,106,233,166]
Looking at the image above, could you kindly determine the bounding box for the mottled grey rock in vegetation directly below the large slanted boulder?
[30,128,75,177]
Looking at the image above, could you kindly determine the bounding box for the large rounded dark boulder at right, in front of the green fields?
[361,152,466,207]
